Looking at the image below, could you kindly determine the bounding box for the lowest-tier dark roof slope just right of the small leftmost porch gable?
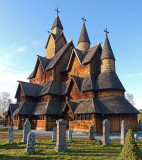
[13,102,35,115]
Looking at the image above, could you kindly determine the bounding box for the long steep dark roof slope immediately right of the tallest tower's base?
[46,41,73,70]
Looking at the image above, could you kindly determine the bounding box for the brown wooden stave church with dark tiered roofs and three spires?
[5,9,139,132]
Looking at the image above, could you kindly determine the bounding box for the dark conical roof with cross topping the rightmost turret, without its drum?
[101,28,115,60]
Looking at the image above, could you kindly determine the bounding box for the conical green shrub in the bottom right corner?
[118,129,141,160]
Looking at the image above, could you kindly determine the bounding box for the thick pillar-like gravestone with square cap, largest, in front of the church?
[55,119,68,152]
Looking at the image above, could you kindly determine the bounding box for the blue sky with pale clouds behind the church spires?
[0,0,142,108]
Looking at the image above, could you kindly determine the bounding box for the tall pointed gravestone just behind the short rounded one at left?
[22,118,31,143]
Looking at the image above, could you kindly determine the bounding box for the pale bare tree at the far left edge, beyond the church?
[0,92,12,114]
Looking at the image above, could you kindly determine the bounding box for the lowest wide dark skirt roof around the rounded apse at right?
[97,96,139,114]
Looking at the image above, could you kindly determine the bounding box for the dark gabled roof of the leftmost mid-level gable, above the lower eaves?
[15,81,39,98]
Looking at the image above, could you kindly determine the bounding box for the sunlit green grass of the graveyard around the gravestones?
[0,127,142,160]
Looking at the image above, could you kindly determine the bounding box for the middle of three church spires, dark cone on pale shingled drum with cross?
[78,17,90,51]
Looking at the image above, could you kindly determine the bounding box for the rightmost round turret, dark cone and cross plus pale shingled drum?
[101,28,115,73]
